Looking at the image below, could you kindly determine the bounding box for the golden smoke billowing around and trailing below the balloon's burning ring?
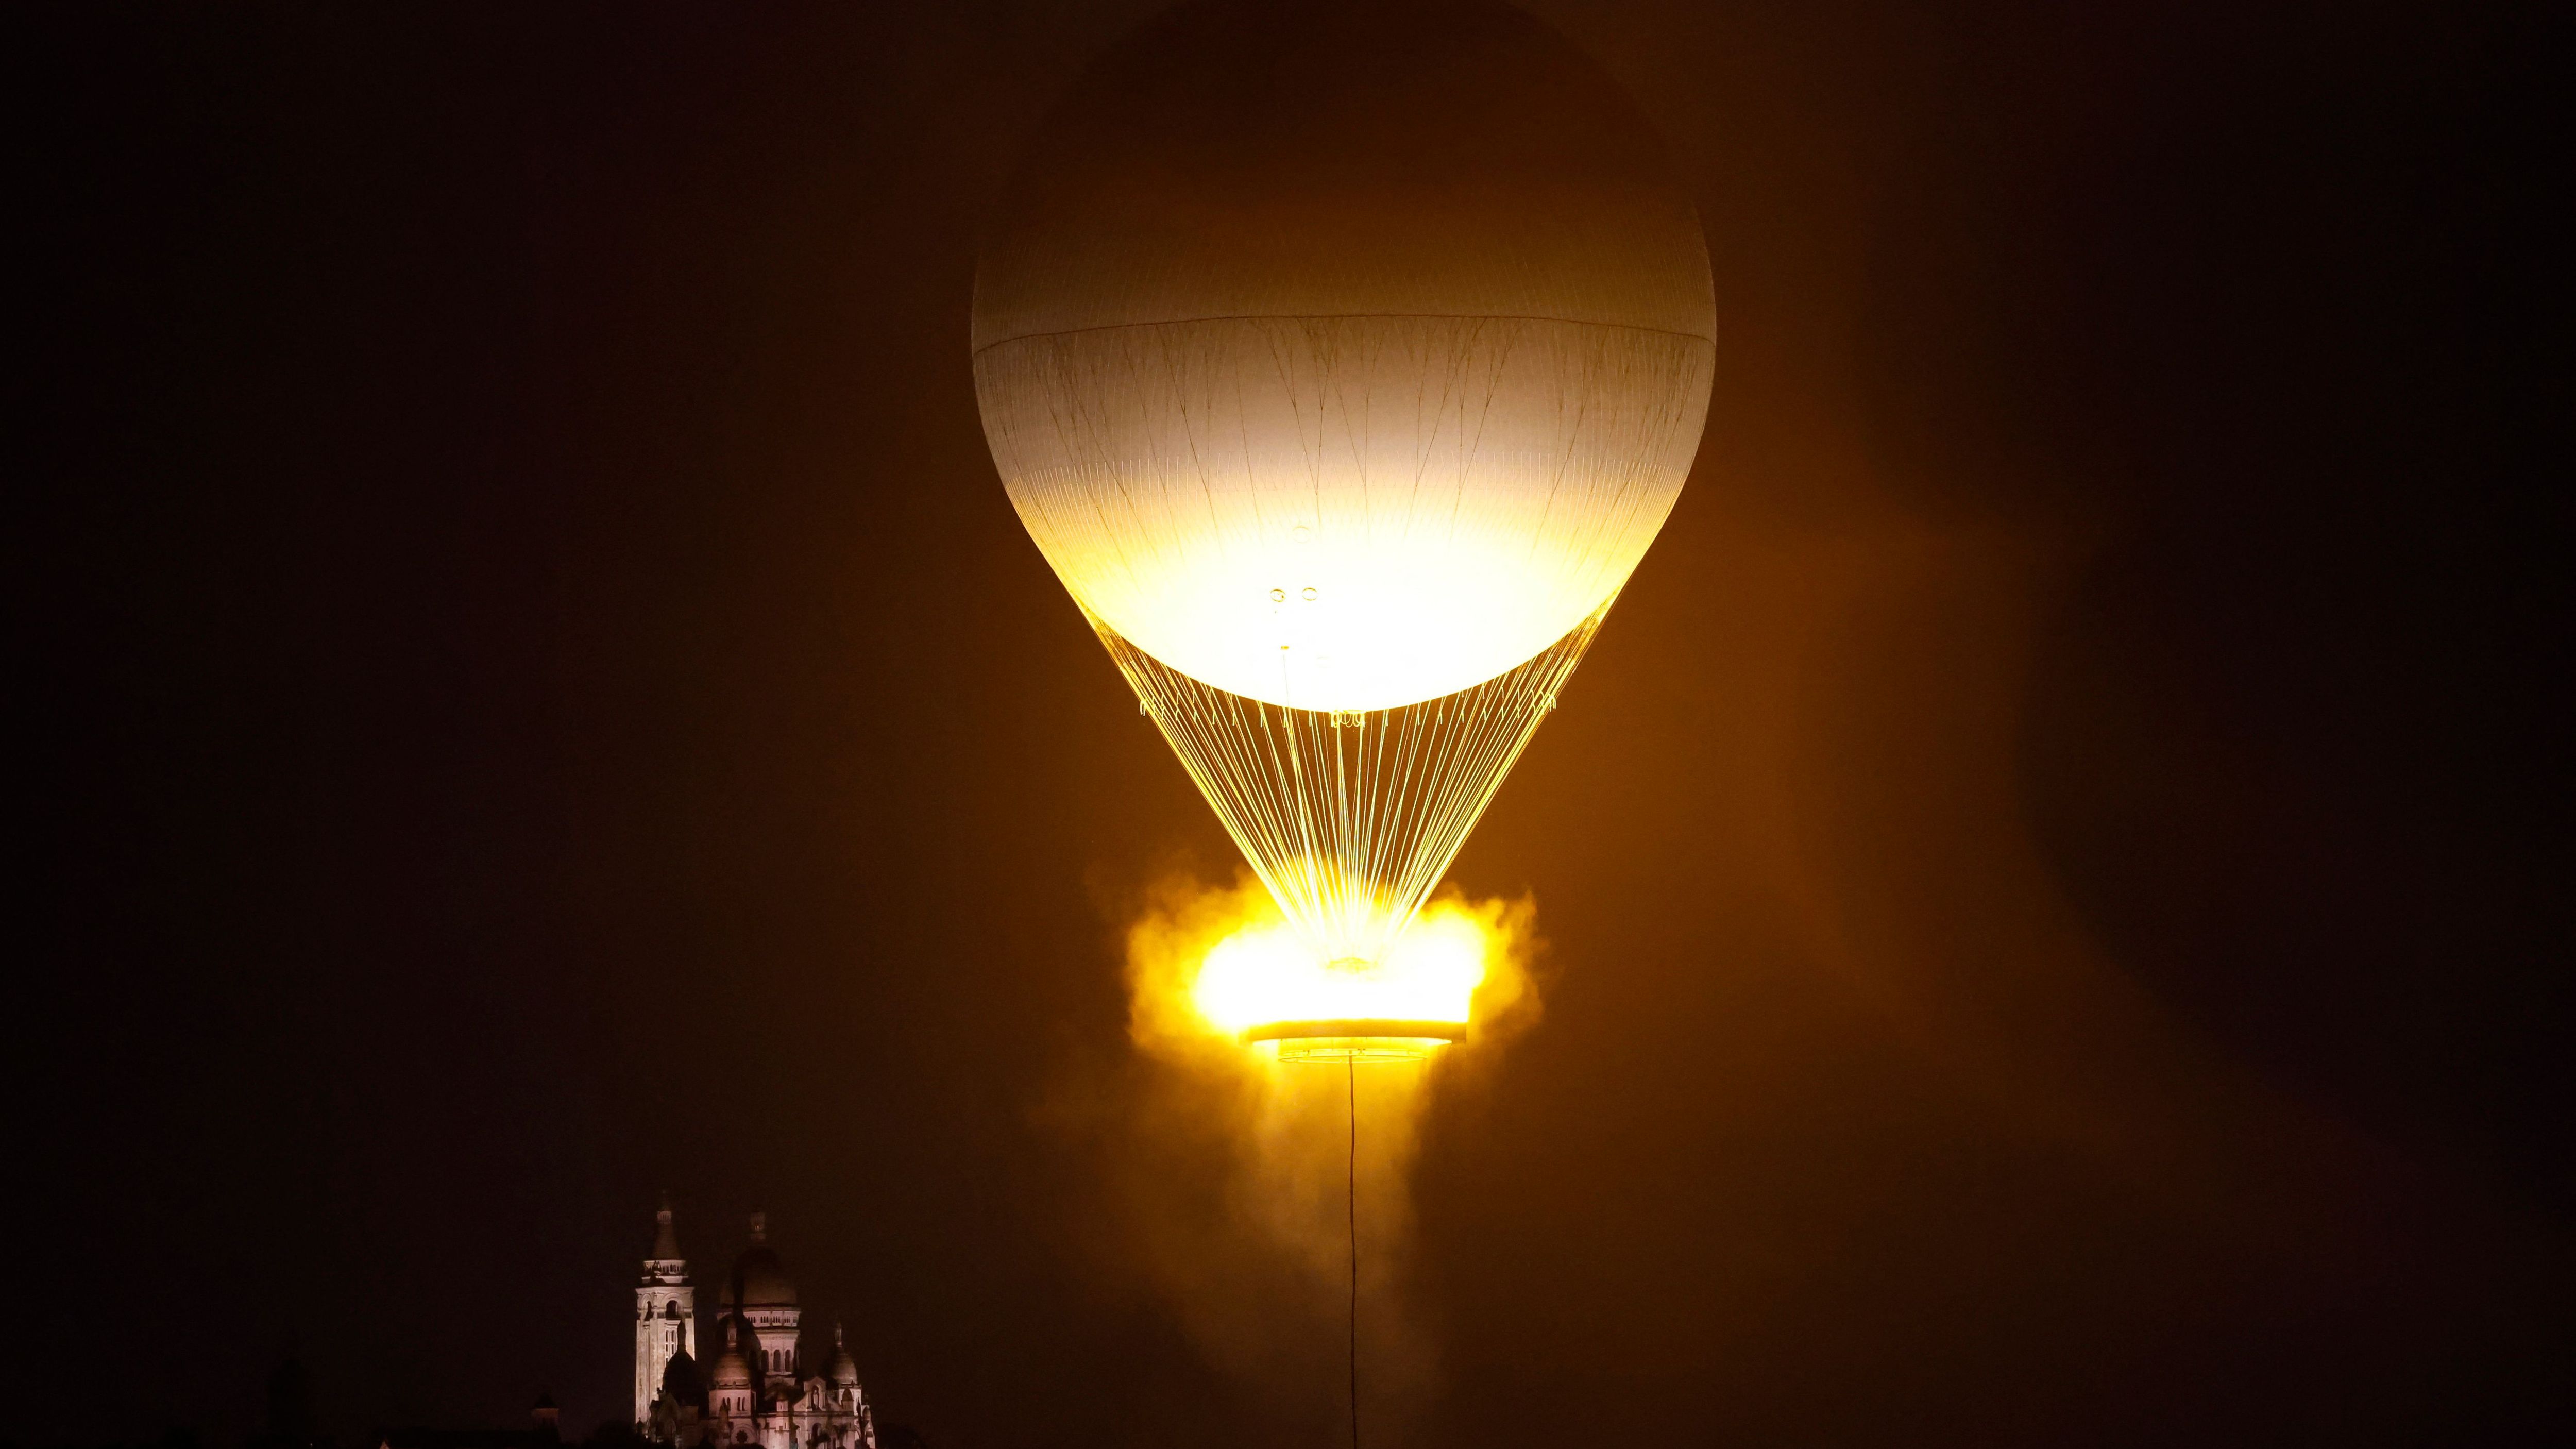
[1069,871,1540,1444]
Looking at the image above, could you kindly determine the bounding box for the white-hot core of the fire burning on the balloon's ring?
[1190,905,1486,1036]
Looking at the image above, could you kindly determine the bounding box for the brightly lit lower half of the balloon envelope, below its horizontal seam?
[979,307,1708,709]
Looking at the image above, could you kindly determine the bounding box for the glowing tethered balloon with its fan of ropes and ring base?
[974,3,1716,1041]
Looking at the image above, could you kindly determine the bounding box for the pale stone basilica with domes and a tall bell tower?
[636,1202,876,1449]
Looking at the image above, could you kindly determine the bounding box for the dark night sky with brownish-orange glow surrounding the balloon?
[0,0,2576,1449]
